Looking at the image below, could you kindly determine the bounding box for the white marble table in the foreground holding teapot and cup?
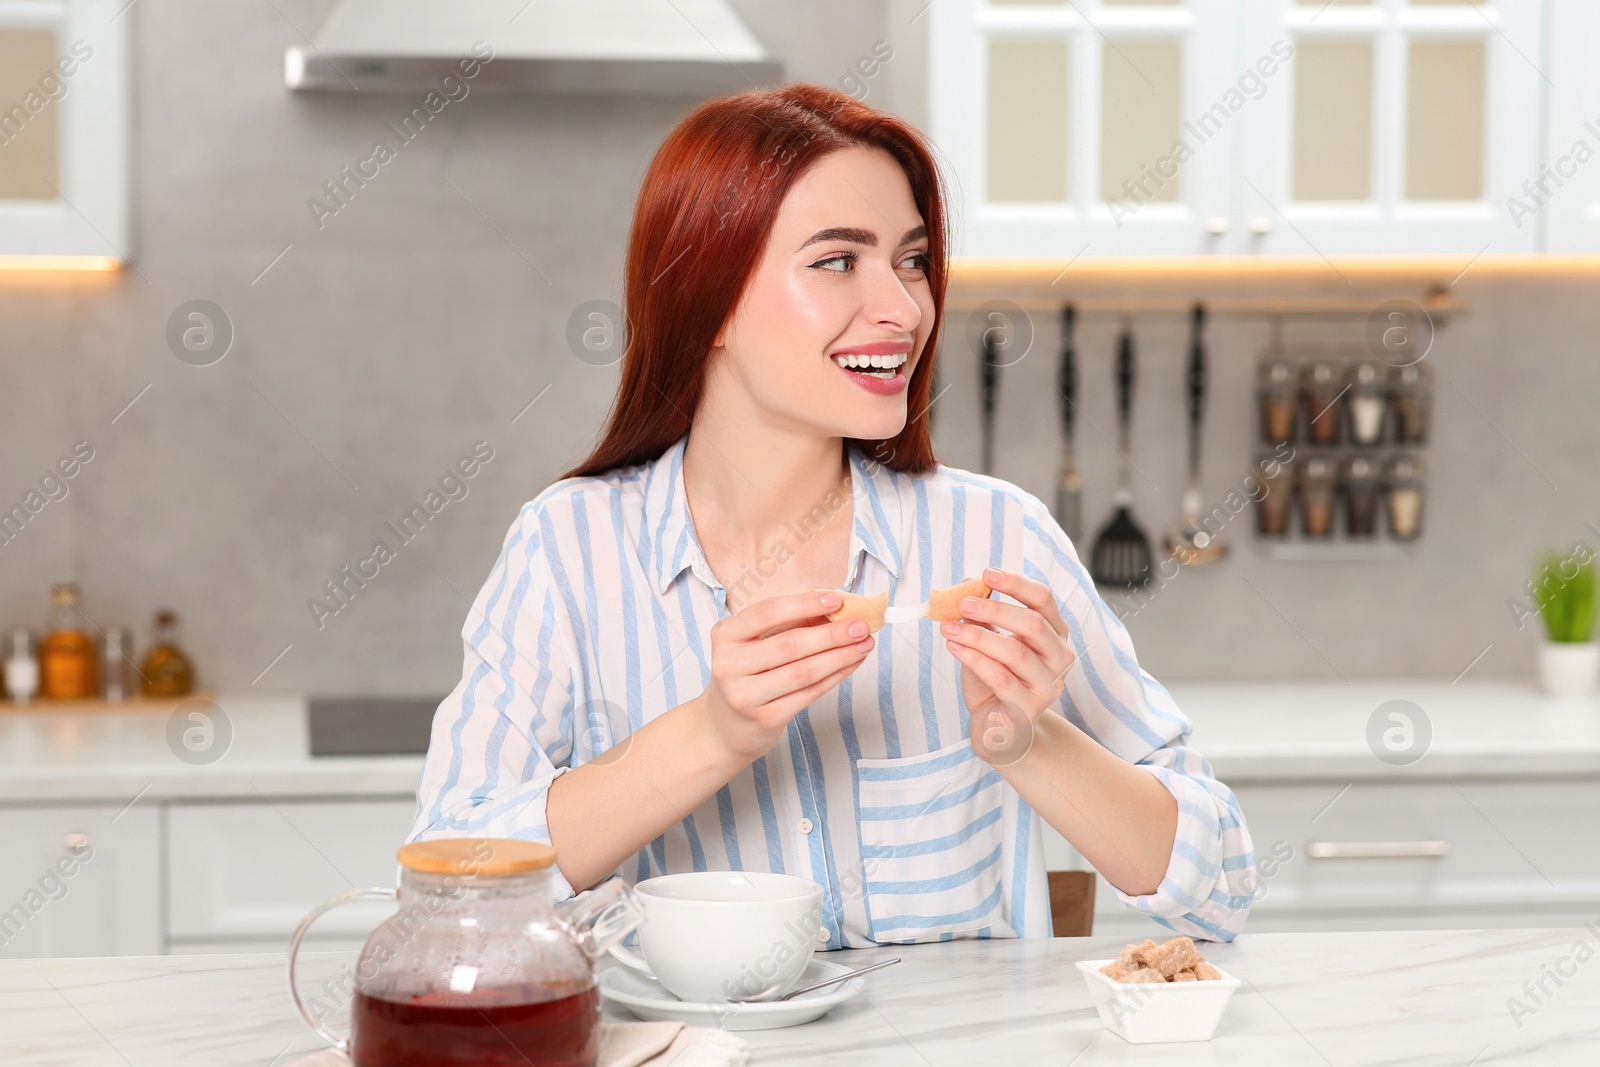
[0,923,1600,1067]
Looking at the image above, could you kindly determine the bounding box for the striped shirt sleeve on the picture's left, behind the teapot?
[408,502,574,901]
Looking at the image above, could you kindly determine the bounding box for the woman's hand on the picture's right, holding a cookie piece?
[939,568,1075,766]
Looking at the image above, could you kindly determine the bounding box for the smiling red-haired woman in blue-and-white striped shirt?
[411,85,1254,949]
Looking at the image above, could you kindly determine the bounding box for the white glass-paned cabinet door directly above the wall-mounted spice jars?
[1238,0,1542,255]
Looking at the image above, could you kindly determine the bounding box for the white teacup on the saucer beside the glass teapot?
[611,870,822,1003]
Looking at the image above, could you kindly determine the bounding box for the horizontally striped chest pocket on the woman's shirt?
[856,739,1011,942]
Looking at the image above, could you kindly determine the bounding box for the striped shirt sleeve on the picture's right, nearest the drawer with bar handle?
[1024,498,1258,941]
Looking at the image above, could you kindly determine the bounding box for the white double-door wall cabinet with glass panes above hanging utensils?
[928,0,1555,255]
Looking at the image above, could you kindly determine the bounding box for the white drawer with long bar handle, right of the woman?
[1235,781,1600,912]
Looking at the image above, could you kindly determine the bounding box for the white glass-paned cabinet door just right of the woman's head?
[928,0,1238,256]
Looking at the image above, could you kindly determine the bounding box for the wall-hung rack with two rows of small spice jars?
[1256,344,1432,561]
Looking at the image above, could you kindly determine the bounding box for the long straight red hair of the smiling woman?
[562,83,949,478]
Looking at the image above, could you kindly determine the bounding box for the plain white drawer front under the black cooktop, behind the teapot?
[166,798,416,947]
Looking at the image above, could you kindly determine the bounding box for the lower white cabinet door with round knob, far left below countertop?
[0,805,162,960]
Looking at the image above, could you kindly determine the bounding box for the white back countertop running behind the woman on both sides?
[0,680,1600,803]
